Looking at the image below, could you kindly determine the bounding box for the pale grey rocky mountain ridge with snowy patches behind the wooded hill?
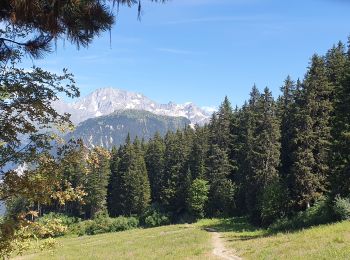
[54,88,210,125]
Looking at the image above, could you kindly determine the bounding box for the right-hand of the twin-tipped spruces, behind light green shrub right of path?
[246,88,280,222]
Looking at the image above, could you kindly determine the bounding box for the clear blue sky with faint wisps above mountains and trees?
[22,0,350,106]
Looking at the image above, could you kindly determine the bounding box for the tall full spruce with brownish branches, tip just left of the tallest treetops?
[292,55,332,209]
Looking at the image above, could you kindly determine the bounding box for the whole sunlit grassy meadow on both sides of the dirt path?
[13,218,350,259]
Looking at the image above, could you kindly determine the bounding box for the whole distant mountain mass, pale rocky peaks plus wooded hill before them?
[53,88,211,148]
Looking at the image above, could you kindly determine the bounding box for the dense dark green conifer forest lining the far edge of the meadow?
[8,38,350,232]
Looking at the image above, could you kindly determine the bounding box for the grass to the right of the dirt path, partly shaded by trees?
[197,218,350,259]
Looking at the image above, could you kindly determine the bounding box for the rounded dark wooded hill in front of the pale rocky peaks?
[68,110,191,149]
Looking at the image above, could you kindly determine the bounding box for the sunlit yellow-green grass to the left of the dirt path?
[16,225,216,260]
